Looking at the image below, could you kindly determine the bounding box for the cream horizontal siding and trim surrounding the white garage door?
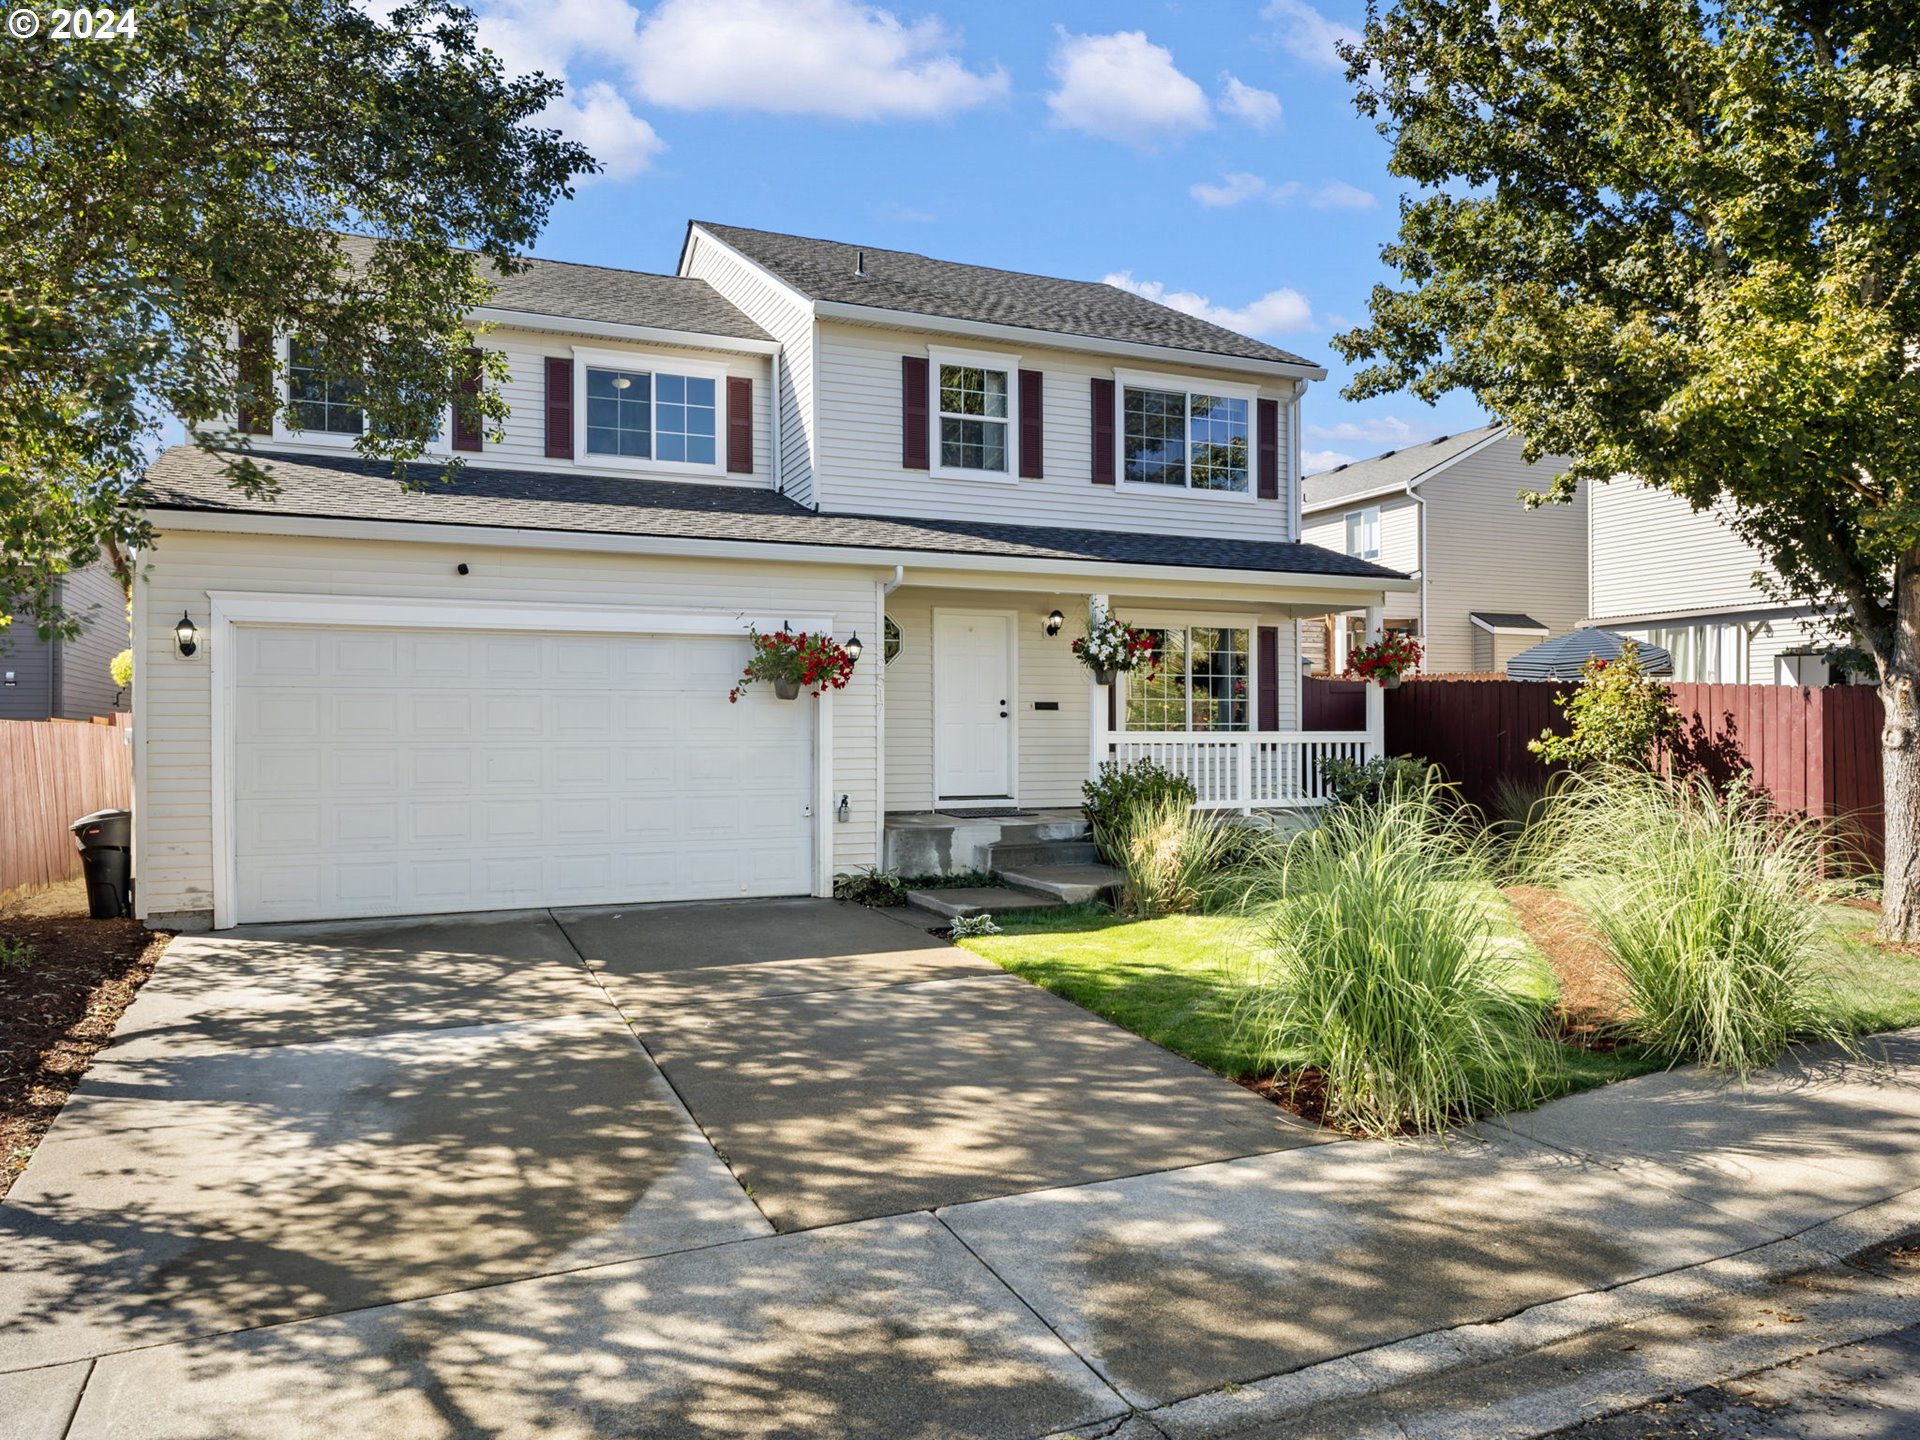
[136,530,879,916]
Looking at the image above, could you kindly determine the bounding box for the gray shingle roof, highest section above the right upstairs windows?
[693,221,1313,365]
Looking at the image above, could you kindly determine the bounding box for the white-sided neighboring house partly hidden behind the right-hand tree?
[1588,480,1836,685]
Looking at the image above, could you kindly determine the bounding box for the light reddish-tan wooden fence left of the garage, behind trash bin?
[0,716,132,895]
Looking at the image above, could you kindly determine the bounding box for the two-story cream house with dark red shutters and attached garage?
[134,223,1411,927]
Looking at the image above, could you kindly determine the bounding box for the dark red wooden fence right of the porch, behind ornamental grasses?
[1386,680,1885,866]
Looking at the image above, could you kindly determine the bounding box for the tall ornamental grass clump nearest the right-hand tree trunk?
[1536,770,1841,1075]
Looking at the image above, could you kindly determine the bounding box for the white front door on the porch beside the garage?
[933,611,1014,801]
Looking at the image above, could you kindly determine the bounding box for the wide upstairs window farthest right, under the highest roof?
[1119,374,1254,495]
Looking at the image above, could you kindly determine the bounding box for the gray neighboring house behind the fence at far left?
[0,564,129,720]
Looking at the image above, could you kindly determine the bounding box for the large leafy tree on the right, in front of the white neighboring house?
[1334,0,1920,941]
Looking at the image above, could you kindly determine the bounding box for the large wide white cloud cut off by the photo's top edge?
[632,0,1008,119]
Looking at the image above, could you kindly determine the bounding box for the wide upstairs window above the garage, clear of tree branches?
[576,351,724,470]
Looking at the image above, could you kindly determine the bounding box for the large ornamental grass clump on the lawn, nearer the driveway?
[1242,776,1561,1137]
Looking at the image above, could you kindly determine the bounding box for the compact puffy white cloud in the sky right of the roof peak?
[1046,31,1213,150]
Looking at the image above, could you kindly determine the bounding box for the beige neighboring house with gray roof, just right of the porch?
[1300,424,1588,674]
